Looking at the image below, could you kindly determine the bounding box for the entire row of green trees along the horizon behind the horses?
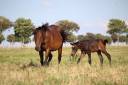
[0,16,128,44]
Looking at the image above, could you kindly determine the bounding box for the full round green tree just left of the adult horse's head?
[14,18,34,44]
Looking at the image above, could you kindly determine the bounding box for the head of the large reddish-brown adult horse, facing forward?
[33,23,48,51]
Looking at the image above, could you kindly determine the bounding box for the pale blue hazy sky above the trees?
[0,0,128,34]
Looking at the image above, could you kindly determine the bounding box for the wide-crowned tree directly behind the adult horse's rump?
[56,20,80,41]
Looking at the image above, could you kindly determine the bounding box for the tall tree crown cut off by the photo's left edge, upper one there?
[0,16,12,33]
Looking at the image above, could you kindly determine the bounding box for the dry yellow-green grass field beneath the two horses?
[0,47,128,85]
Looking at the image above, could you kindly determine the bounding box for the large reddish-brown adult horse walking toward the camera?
[33,23,65,65]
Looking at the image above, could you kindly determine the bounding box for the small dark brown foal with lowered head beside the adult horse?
[70,39,111,66]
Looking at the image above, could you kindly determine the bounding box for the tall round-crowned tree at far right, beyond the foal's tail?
[107,19,127,41]
